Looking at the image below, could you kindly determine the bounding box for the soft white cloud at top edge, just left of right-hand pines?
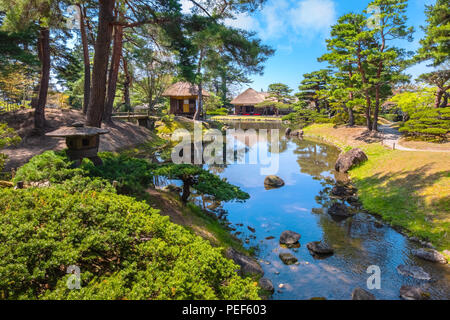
[289,0,336,36]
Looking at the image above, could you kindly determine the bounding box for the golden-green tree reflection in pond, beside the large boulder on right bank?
[294,140,339,179]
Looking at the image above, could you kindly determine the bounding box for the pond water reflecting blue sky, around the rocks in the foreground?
[207,122,450,299]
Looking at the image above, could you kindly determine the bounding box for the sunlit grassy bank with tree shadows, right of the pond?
[304,124,450,250]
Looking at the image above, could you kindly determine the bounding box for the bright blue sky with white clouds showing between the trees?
[218,0,435,91]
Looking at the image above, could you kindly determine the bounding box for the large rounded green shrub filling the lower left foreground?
[0,187,258,299]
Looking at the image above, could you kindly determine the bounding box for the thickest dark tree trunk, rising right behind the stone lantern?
[86,0,115,127]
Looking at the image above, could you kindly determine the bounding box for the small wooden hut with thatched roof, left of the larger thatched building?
[162,82,210,117]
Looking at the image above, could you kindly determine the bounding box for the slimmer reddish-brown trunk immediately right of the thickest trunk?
[103,12,123,122]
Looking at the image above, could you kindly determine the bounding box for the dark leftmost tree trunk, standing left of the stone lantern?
[34,28,50,134]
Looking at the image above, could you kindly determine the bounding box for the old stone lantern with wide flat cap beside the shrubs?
[46,122,109,166]
